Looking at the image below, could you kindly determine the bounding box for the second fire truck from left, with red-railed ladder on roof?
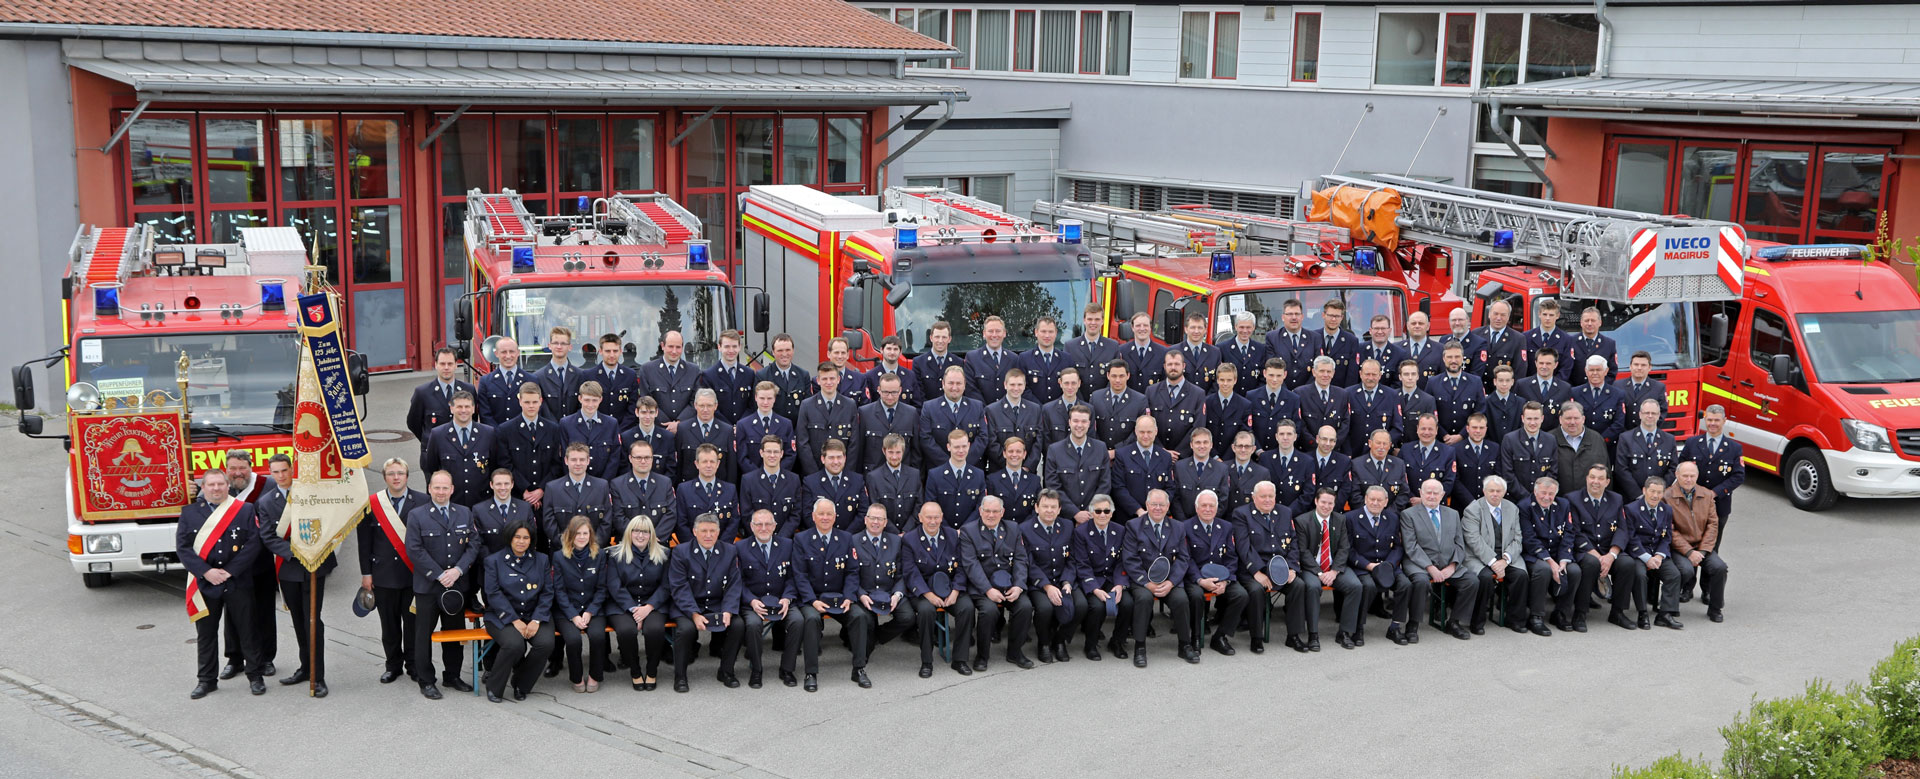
[453,190,766,372]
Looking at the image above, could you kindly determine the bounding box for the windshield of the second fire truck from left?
[497,284,732,368]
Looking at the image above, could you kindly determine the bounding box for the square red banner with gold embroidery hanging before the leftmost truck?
[67,409,190,522]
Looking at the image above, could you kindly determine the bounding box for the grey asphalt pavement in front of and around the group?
[0,376,1920,779]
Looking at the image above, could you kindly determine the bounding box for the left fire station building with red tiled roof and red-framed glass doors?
[0,0,966,370]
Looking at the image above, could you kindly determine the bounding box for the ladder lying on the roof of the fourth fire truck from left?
[1033,200,1352,255]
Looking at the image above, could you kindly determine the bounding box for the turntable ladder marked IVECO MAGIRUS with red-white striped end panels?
[1321,175,1747,303]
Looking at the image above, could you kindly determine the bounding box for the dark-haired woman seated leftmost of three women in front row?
[486,522,553,702]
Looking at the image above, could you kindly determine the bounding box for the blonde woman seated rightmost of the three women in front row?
[601,516,668,691]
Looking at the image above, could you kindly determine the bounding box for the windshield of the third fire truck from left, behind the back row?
[893,280,1087,353]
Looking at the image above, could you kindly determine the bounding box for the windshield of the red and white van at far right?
[1799,309,1920,384]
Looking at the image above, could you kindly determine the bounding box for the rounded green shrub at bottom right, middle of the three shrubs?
[1720,679,1885,779]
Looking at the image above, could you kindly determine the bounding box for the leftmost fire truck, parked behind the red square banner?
[13,224,367,587]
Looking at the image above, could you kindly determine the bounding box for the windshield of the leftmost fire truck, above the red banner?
[73,332,300,434]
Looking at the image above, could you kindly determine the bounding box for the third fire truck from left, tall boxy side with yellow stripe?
[741,184,1112,363]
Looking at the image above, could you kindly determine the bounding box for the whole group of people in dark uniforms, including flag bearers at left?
[179,299,1745,702]
